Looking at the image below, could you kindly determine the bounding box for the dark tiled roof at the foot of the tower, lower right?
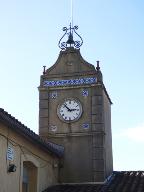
[43,171,144,192]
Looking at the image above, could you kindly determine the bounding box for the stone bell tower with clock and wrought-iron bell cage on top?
[39,25,113,183]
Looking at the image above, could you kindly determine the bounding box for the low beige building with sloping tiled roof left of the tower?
[0,109,63,192]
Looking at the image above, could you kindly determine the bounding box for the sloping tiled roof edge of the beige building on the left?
[0,108,64,157]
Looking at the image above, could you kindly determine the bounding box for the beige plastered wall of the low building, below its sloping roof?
[0,123,58,192]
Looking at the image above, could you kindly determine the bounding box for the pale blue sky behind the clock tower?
[0,0,144,170]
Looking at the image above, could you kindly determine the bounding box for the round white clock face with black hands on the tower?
[57,98,82,123]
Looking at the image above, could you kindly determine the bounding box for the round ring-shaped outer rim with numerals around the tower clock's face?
[57,97,83,123]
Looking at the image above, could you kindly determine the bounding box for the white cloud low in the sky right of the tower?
[115,124,144,143]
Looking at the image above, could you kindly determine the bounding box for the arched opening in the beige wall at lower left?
[22,161,37,192]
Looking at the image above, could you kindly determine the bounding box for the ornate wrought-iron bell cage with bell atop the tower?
[58,23,83,50]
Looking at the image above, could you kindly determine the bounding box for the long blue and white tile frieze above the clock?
[43,77,97,87]
